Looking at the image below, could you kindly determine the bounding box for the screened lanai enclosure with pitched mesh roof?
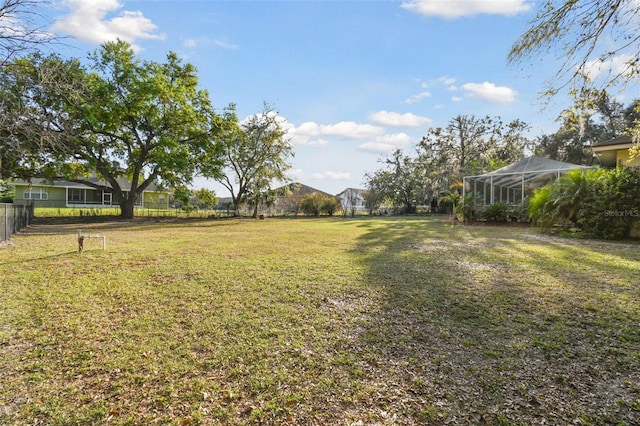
[462,157,588,207]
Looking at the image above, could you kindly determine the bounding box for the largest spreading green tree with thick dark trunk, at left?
[0,41,225,218]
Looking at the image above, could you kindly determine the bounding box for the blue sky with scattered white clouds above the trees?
[38,0,636,196]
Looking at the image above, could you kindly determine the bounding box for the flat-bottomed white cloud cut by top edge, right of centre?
[401,0,533,19]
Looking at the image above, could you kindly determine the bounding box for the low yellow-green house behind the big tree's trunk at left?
[9,177,169,209]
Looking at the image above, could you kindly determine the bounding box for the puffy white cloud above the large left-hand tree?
[52,0,164,50]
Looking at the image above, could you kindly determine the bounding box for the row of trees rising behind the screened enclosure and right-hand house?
[365,89,640,213]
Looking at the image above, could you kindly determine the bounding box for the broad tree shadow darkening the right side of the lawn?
[356,219,640,424]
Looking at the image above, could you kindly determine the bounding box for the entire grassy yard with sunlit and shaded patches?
[0,218,640,425]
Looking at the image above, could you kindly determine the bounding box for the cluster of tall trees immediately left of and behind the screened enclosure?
[366,116,529,213]
